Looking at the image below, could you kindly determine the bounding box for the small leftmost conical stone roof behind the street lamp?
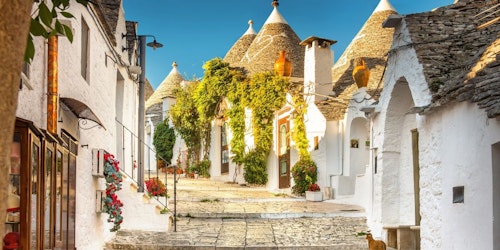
[146,62,184,109]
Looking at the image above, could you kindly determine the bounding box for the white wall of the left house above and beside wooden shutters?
[17,4,137,249]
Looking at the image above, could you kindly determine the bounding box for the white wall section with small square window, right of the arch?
[421,102,500,249]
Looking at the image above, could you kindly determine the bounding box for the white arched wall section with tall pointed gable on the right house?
[368,18,430,236]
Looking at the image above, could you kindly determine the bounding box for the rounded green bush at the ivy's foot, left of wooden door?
[243,149,268,185]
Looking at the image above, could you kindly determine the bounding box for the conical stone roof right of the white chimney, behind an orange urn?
[316,0,397,120]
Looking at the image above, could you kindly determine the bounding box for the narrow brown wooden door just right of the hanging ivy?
[278,118,290,188]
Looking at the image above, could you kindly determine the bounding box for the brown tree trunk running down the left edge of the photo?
[0,0,88,238]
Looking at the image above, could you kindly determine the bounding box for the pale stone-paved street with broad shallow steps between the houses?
[106,178,367,250]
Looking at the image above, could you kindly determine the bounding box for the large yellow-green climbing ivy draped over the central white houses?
[170,58,296,184]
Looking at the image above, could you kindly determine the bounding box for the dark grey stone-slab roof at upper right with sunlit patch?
[402,0,500,118]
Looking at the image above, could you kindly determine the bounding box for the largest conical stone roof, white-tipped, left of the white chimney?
[241,1,305,77]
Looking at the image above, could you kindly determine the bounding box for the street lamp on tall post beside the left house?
[137,35,163,193]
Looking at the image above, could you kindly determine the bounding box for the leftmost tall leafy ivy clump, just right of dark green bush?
[169,83,201,165]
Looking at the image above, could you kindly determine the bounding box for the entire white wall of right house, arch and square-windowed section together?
[368,17,500,249]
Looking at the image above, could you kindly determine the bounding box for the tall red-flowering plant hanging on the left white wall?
[103,154,123,232]
